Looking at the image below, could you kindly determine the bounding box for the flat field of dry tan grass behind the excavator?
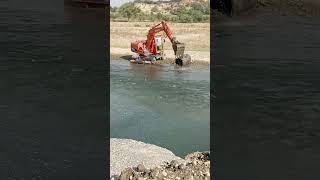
[110,22,210,53]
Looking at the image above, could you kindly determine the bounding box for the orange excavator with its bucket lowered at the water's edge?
[131,21,191,66]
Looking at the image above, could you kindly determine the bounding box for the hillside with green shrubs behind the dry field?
[110,0,210,23]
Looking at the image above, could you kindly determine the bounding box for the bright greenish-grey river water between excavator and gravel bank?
[110,60,210,157]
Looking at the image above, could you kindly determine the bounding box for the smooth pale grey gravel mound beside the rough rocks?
[110,138,184,177]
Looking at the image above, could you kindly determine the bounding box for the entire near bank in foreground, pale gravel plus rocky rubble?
[110,138,210,180]
